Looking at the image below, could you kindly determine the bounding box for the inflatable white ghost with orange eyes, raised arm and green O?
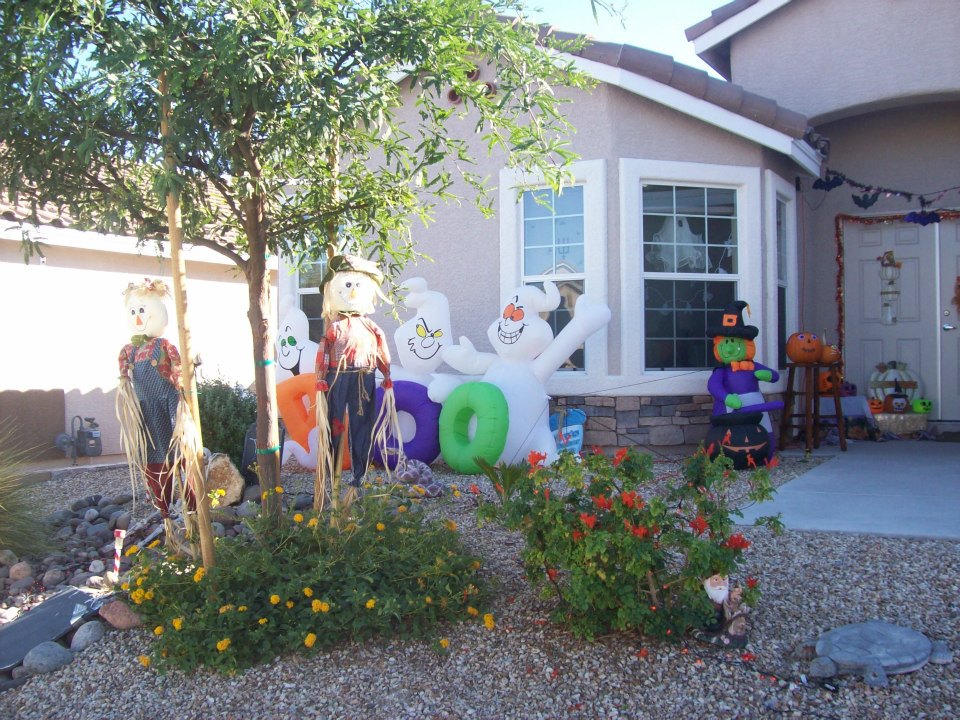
[430,281,610,473]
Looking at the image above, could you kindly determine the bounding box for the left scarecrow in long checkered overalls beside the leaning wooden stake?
[117,278,197,550]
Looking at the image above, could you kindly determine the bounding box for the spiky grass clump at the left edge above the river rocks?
[0,422,56,556]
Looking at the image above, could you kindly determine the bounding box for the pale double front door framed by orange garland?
[843,221,960,421]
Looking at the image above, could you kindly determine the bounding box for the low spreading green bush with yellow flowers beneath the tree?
[126,484,493,672]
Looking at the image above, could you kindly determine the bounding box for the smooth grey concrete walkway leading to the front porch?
[737,440,960,540]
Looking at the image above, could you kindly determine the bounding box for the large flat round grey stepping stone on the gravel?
[817,620,933,675]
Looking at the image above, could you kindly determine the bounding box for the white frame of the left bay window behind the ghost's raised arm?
[499,159,608,395]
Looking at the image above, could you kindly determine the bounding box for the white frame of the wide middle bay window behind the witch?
[620,158,760,395]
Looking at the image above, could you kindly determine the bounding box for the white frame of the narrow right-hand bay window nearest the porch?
[757,170,800,376]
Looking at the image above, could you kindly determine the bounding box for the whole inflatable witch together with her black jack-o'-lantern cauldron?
[707,300,783,470]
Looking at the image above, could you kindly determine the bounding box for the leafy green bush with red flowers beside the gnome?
[478,448,779,639]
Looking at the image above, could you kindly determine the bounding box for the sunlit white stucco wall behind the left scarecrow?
[0,221,276,455]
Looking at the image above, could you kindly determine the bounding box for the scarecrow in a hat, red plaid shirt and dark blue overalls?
[314,255,400,508]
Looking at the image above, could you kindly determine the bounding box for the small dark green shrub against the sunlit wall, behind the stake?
[197,380,257,469]
